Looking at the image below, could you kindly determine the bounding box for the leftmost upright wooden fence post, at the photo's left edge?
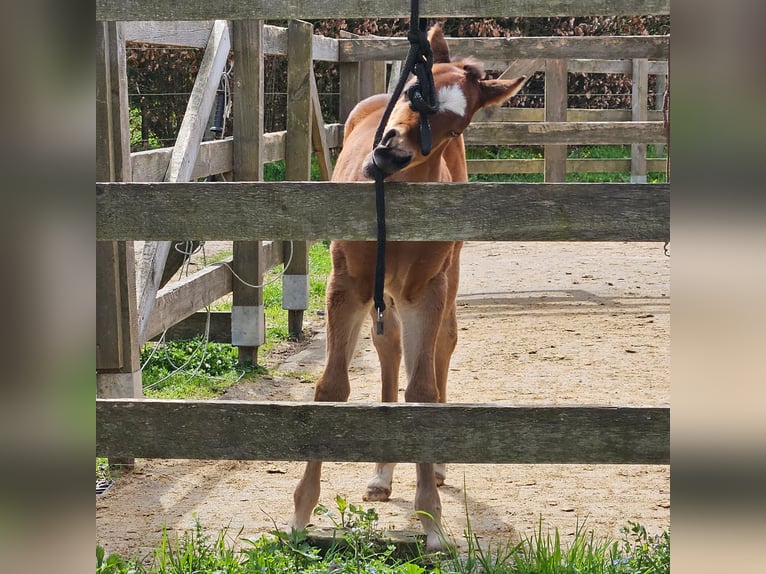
[96,22,142,468]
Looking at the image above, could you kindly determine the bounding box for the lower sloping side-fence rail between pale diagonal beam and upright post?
[146,257,232,341]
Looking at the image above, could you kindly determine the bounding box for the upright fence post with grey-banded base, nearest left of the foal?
[282,20,314,338]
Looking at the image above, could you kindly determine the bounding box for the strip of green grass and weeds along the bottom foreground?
[96,496,670,574]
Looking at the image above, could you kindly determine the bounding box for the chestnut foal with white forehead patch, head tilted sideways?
[290,27,525,550]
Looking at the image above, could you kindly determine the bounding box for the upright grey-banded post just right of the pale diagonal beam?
[231,20,266,365]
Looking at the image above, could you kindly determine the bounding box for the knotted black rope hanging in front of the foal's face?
[372,0,438,335]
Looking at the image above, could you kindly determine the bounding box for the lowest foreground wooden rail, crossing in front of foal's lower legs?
[96,399,670,464]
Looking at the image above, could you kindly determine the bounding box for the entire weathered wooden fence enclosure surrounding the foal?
[96,0,670,472]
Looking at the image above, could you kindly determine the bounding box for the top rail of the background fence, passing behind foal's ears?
[338,36,670,62]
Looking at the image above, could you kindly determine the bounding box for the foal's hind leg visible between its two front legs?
[363,298,402,502]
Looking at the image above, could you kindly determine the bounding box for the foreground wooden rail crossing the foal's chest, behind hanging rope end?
[96,182,670,241]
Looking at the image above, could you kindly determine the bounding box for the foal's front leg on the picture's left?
[289,272,369,530]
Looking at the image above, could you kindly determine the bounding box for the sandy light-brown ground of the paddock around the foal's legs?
[96,243,670,556]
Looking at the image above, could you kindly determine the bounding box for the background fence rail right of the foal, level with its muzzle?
[463,122,665,145]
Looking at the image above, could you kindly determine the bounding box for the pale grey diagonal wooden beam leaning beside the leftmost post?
[137,20,231,343]
